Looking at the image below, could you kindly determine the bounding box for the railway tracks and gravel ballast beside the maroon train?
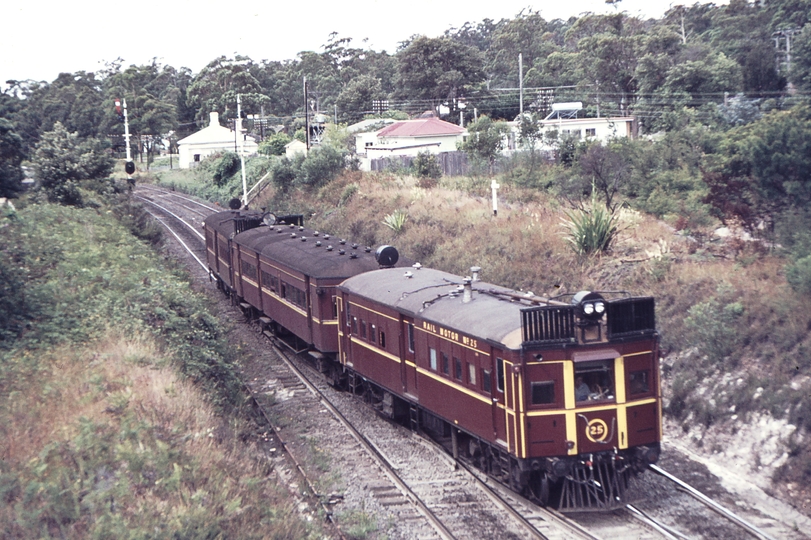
[136,187,804,539]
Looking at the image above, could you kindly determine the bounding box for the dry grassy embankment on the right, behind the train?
[152,158,811,504]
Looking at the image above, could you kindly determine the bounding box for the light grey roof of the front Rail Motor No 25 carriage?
[340,268,529,349]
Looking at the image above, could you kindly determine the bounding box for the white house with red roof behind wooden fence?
[355,117,467,170]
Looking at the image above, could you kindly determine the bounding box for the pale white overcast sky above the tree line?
[0,0,727,88]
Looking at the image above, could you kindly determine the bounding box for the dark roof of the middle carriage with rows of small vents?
[234,225,410,279]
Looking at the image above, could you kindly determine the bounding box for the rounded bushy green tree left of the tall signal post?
[33,122,115,206]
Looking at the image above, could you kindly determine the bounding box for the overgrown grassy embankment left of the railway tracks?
[0,201,321,538]
